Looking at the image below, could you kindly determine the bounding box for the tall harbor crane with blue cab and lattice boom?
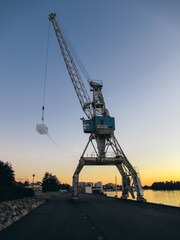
[49,13,144,201]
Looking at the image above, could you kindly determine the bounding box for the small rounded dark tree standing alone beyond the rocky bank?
[42,172,60,192]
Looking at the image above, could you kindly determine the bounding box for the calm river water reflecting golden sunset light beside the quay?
[105,189,180,207]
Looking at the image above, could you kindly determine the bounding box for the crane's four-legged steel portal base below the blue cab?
[72,133,146,202]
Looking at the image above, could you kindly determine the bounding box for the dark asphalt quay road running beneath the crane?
[0,193,180,240]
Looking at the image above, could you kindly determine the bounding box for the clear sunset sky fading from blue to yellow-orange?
[0,0,180,185]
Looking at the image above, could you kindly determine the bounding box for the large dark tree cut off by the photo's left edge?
[0,160,15,186]
